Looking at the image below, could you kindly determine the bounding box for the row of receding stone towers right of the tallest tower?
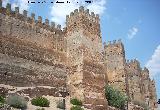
[104,41,157,109]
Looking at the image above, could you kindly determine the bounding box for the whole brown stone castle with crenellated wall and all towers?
[0,0,157,110]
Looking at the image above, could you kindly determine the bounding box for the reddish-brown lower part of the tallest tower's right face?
[82,60,107,110]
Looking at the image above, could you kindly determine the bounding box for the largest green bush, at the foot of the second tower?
[105,85,128,109]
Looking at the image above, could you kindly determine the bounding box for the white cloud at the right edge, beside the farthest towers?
[145,45,160,78]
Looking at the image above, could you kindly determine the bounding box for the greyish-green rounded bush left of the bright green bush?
[6,95,27,110]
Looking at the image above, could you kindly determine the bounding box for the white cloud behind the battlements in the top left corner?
[2,0,29,13]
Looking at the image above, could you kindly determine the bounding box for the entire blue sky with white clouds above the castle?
[3,0,160,98]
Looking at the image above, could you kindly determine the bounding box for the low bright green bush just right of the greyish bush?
[31,97,50,107]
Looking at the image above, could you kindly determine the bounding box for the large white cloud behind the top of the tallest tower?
[51,0,106,26]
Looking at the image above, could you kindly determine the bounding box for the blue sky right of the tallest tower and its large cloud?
[101,0,160,98]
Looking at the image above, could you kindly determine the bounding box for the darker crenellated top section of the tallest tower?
[66,6,102,43]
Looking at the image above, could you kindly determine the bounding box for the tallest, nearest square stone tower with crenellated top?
[65,6,107,110]
